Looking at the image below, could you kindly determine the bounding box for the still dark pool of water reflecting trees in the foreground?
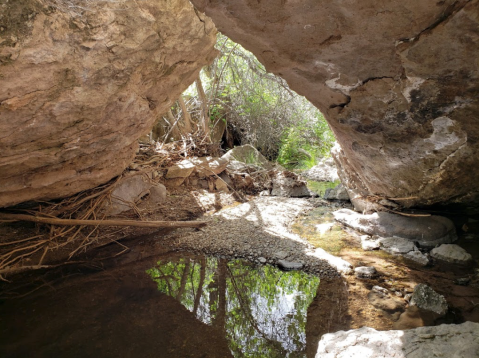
[0,253,329,358]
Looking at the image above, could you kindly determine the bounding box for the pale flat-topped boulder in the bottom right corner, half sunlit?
[316,322,479,358]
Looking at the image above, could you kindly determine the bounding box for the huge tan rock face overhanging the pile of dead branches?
[0,0,216,207]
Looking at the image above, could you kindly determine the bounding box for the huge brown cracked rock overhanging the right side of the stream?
[192,0,479,206]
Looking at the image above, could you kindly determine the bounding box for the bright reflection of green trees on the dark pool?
[147,256,319,358]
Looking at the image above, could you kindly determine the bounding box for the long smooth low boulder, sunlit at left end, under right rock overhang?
[333,209,457,248]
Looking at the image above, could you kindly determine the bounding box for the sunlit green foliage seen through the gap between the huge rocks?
[189,34,334,162]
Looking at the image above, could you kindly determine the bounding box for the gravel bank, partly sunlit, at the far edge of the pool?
[164,197,348,278]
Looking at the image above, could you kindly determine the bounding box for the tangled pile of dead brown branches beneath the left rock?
[0,136,220,281]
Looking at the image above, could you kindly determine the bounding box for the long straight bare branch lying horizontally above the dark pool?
[0,213,206,228]
